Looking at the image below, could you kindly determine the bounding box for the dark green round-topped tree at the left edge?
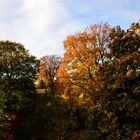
[0,41,38,139]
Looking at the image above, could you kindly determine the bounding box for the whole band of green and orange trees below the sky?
[0,23,140,140]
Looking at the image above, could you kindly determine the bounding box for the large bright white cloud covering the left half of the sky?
[0,0,85,57]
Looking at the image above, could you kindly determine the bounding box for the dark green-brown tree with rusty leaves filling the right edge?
[93,23,140,140]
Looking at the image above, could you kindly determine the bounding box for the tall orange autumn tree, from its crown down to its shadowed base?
[57,23,110,133]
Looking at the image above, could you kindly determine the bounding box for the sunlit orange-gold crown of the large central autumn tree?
[58,23,110,107]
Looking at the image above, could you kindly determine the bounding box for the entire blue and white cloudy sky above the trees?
[0,0,140,58]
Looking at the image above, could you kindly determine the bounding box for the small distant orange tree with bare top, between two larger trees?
[37,55,60,93]
